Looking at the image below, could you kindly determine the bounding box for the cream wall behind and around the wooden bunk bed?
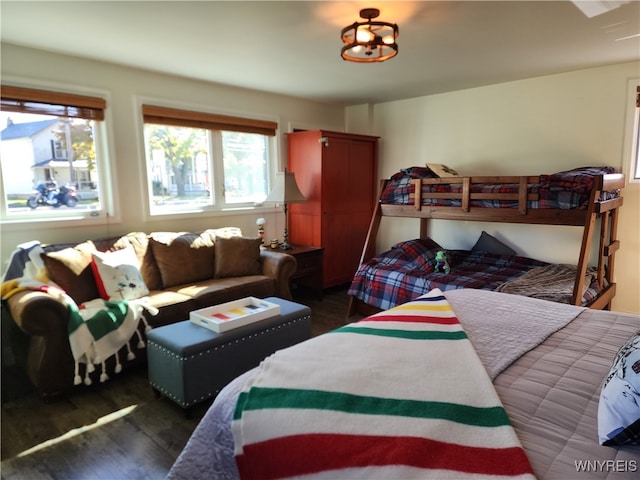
[346,62,640,313]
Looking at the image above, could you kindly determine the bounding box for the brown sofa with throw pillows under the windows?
[3,227,297,399]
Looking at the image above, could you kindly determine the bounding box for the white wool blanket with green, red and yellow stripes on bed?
[231,290,533,479]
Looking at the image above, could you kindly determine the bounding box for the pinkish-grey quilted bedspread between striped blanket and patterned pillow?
[493,310,640,480]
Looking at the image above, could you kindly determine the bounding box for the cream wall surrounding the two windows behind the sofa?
[0,44,344,270]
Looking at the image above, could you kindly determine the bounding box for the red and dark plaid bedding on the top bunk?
[380,167,617,210]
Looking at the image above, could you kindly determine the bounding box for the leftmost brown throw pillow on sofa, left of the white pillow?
[41,241,100,305]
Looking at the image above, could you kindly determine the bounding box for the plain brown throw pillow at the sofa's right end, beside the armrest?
[215,237,262,278]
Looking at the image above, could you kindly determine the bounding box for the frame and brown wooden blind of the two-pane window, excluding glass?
[138,105,279,220]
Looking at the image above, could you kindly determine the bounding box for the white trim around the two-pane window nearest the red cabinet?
[134,95,281,222]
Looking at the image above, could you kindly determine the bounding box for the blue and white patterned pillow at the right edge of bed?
[598,332,640,446]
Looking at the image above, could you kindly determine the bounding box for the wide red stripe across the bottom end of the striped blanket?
[236,434,533,480]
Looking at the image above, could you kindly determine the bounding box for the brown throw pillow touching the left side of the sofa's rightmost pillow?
[150,232,215,288]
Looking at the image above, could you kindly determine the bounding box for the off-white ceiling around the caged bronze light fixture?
[0,0,640,104]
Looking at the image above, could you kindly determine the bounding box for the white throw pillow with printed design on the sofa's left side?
[91,246,149,301]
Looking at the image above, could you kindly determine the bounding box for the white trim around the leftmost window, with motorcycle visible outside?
[0,76,121,227]
